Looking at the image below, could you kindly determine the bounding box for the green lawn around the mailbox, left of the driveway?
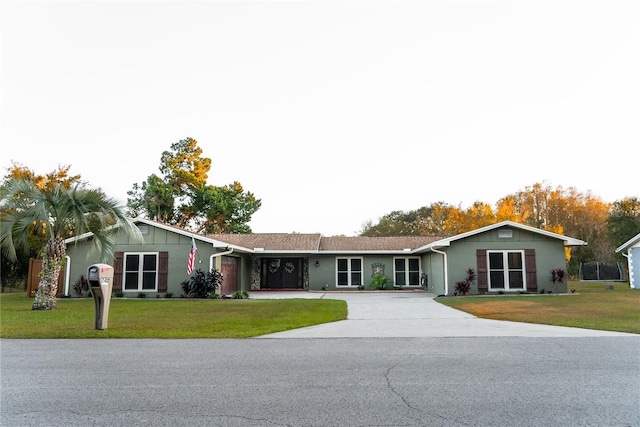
[0,293,347,338]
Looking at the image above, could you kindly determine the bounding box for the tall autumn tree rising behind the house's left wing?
[127,138,261,233]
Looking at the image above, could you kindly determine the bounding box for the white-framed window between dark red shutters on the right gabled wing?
[487,251,526,291]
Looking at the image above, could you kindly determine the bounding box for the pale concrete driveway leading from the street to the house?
[250,291,637,338]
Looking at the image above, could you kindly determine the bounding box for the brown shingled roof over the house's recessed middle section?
[207,233,441,252]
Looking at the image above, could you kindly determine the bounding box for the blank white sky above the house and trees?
[0,0,640,235]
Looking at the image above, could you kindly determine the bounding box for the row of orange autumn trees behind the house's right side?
[359,183,640,270]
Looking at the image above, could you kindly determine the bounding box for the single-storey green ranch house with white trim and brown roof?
[64,219,586,296]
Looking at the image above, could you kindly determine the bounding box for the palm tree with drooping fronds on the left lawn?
[0,179,142,310]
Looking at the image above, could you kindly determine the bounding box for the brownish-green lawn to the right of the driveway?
[436,282,640,334]
